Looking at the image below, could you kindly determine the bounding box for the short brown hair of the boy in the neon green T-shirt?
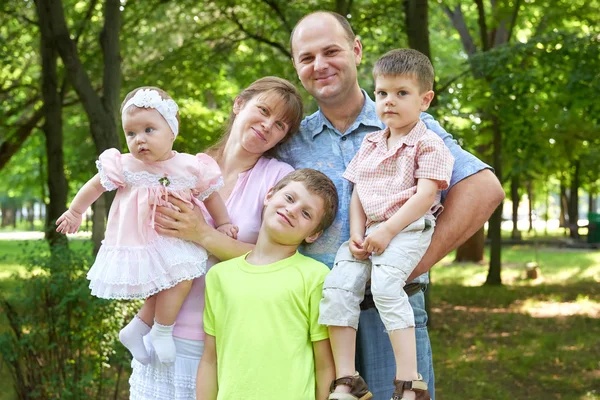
[273,168,338,232]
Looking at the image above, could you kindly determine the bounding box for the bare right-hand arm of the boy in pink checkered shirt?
[363,178,438,255]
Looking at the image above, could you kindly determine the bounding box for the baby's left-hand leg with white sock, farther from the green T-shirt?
[119,296,156,365]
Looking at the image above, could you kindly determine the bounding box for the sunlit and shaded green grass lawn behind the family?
[0,236,600,400]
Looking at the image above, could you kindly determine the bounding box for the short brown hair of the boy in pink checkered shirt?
[373,49,434,92]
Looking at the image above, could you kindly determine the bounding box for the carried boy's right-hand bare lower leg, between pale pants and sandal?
[390,327,419,400]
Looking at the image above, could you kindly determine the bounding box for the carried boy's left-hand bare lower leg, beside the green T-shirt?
[328,326,356,393]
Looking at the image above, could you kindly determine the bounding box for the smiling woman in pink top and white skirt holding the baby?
[129,77,302,400]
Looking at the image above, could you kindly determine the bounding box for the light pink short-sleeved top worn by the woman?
[173,157,294,340]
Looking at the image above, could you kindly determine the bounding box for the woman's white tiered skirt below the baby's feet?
[129,336,204,400]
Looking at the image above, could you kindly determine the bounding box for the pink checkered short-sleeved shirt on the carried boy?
[344,121,454,226]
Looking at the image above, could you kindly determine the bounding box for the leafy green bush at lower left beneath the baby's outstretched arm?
[0,246,133,399]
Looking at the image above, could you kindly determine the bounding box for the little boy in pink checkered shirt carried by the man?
[319,49,454,400]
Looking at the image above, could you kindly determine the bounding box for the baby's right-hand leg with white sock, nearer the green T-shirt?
[150,281,192,364]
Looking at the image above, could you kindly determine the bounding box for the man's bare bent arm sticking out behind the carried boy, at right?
[407,169,504,282]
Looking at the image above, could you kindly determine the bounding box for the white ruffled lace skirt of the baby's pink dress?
[87,236,208,300]
